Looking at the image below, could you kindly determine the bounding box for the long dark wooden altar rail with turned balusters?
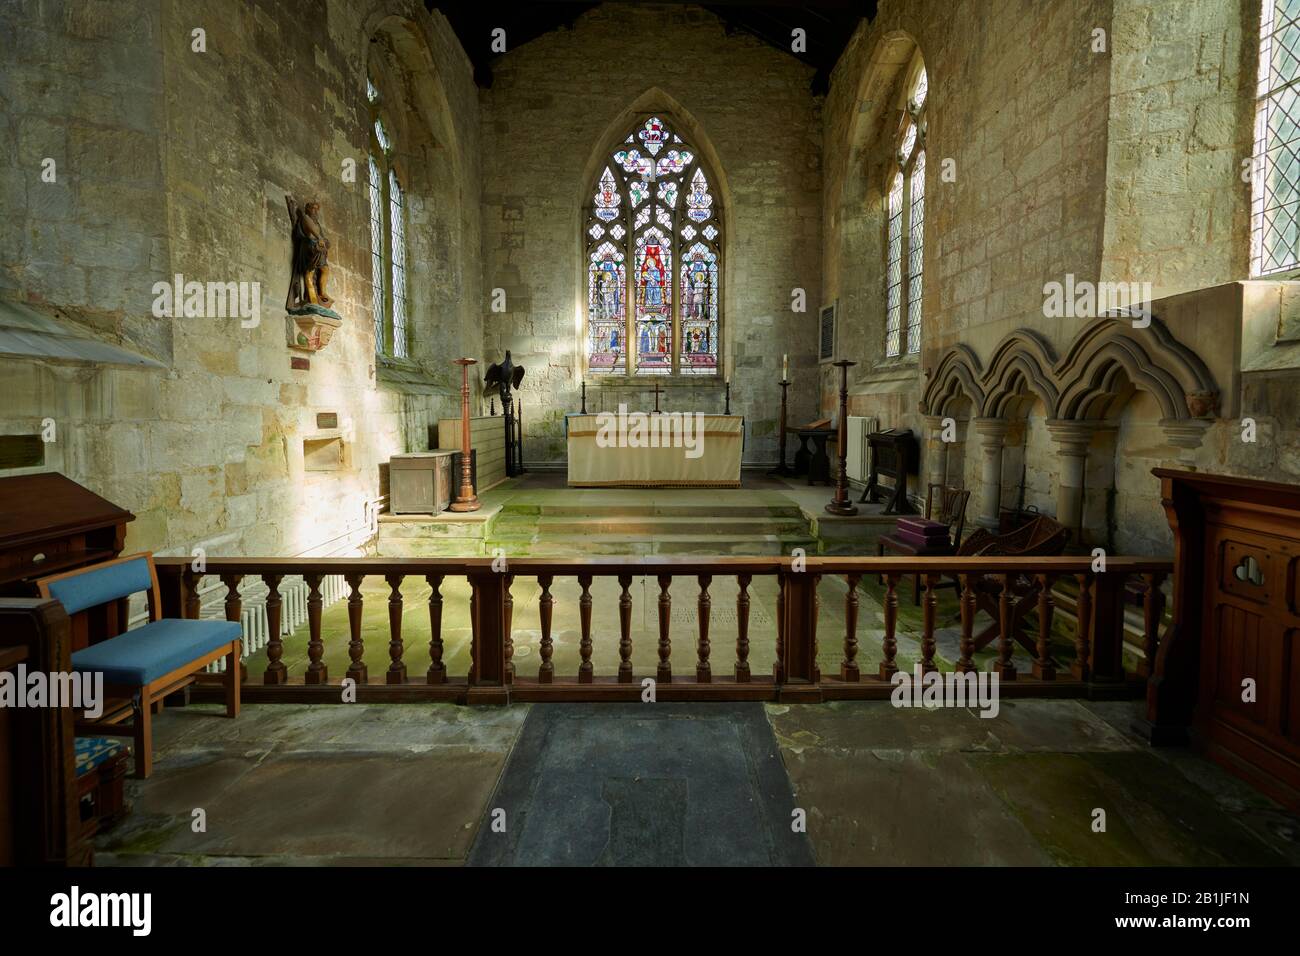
[149,555,1173,704]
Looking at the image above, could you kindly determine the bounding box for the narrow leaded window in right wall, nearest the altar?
[884,55,930,358]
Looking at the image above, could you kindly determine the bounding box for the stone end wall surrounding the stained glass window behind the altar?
[481,4,822,466]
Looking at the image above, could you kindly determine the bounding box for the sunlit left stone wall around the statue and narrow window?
[0,0,481,555]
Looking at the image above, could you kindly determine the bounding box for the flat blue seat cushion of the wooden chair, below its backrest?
[73,618,241,684]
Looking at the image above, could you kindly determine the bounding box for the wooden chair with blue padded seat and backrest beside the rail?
[36,551,242,778]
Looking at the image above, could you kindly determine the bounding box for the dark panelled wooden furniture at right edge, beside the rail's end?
[1147,468,1300,809]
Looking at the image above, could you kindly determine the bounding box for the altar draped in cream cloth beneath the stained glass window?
[564,406,745,488]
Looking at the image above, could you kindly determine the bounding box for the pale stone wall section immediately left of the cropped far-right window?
[1102,0,1260,297]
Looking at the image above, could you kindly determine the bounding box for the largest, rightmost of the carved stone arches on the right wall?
[1056,317,1218,420]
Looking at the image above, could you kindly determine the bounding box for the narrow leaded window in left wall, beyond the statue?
[365,77,411,359]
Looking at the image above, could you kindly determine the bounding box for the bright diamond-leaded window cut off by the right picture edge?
[1251,0,1300,276]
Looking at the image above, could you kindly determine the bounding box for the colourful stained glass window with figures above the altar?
[582,116,723,376]
